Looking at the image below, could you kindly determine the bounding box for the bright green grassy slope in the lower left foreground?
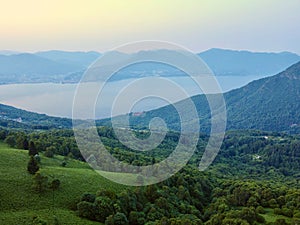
[0,143,124,225]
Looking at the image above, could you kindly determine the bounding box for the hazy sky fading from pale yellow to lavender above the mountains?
[0,0,300,54]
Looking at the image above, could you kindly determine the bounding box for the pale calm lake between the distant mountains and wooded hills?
[0,76,261,119]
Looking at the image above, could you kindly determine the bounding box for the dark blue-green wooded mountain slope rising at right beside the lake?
[98,62,300,132]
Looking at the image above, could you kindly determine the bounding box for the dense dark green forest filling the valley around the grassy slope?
[0,127,300,225]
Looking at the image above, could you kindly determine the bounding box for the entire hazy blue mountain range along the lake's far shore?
[0,49,300,84]
